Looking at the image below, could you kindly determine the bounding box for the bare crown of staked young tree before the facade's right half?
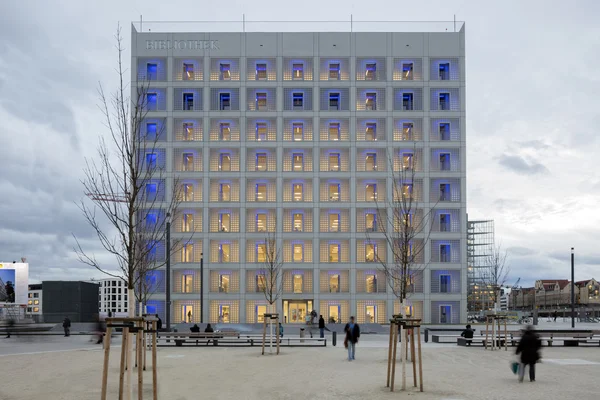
[366,147,433,315]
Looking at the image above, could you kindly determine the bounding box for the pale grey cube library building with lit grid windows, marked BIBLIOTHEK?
[131,22,467,323]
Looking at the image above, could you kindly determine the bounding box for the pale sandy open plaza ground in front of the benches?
[0,335,600,400]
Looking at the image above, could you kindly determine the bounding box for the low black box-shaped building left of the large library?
[42,281,98,323]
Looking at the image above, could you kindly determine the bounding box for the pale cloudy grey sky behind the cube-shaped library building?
[0,0,600,286]
